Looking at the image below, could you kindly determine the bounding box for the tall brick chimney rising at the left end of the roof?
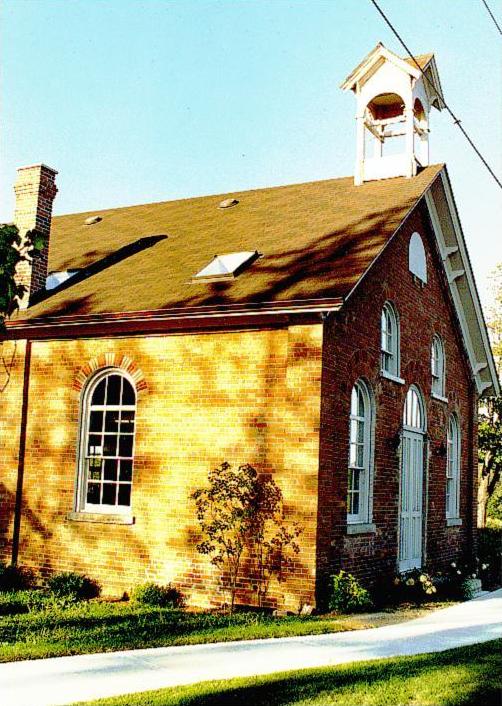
[14,164,57,309]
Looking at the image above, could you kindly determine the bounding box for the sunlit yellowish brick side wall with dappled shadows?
[0,325,322,609]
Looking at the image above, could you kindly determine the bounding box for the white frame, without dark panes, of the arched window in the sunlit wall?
[75,367,138,516]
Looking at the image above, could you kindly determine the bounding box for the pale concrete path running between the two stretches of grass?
[0,589,502,706]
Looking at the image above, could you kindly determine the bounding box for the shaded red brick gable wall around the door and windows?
[318,199,476,597]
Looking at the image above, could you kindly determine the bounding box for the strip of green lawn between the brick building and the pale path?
[0,601,452,662]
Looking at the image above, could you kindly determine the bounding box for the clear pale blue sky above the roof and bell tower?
[0,0,502,306]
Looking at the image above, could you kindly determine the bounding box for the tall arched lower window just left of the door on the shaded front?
[347,380,373,523]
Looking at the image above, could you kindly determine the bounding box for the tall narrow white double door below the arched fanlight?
[399,430,424,571]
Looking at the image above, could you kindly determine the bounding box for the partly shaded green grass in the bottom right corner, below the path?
[73,640,502,706]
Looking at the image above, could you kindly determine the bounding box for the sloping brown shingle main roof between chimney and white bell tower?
[18,165,442,319]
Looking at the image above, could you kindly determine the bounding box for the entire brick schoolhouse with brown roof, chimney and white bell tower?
[0,44,498,609]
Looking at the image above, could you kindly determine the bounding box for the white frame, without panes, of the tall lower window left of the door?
[347,380,375,525]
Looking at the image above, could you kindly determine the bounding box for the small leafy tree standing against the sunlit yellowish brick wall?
[191,461,299,612]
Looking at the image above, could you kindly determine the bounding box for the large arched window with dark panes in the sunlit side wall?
[77,369,136,512]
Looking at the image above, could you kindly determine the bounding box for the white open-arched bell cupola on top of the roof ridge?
[341,43,444,184]
